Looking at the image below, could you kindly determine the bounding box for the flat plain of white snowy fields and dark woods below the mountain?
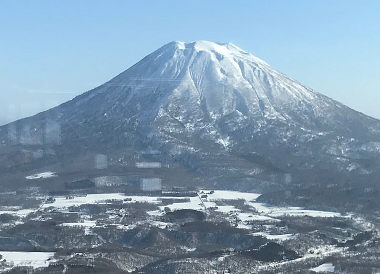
[0,189,378,273]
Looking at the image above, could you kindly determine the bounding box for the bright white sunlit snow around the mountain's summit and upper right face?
[145,41,317,124]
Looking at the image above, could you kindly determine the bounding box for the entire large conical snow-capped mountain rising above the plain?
[0,41,380,194]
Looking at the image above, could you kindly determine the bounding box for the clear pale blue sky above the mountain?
[0,0,380,123]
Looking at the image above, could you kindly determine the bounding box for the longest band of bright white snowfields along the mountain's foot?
[37,190,342,226]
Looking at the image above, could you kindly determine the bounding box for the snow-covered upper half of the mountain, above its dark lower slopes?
[37,41,378,161]
